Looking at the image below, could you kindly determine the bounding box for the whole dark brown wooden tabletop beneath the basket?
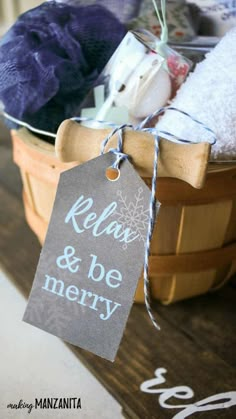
[0,130,236,419]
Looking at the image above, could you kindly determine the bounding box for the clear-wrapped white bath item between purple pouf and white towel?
[81,30,191,123]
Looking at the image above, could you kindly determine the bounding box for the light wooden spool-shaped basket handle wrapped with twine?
[55,119,211,189]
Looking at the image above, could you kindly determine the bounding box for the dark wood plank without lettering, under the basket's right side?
[158,284,236,367]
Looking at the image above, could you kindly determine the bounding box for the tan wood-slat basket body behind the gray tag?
[12,129,236,304]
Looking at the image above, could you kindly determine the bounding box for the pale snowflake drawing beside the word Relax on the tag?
[114,188,149,249]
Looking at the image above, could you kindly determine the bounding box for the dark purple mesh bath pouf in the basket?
[0,1,126,136]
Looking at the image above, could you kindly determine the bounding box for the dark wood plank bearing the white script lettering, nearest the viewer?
[70,306,236,419]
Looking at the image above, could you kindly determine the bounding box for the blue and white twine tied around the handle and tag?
[1,106,216,330]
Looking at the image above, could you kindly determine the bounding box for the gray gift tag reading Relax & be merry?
[23,153,150,361]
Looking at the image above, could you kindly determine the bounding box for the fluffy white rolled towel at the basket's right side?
[157,27,236,160]
